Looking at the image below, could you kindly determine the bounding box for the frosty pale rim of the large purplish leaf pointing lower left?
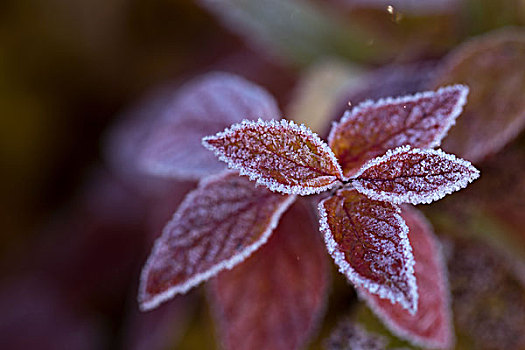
[138,171,296,311]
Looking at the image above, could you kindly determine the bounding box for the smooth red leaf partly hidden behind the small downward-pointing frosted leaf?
[358,207,454,349]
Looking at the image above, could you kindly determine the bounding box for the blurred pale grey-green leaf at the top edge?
[199,0,392,64]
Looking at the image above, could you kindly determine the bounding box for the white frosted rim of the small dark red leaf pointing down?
[317,198,419,314]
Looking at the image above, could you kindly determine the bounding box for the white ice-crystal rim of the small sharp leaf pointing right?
[351,145,480,205]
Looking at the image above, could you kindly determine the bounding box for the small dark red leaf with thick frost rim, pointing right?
[352,146,479,204]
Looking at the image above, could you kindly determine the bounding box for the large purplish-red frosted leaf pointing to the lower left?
[139,172,294,310]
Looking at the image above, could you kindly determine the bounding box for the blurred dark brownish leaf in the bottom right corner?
[449,237,525,349]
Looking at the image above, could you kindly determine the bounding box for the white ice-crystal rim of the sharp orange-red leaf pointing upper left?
[202,118,346,196]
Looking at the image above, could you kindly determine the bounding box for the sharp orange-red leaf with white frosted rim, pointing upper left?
[203,119,343,195]
